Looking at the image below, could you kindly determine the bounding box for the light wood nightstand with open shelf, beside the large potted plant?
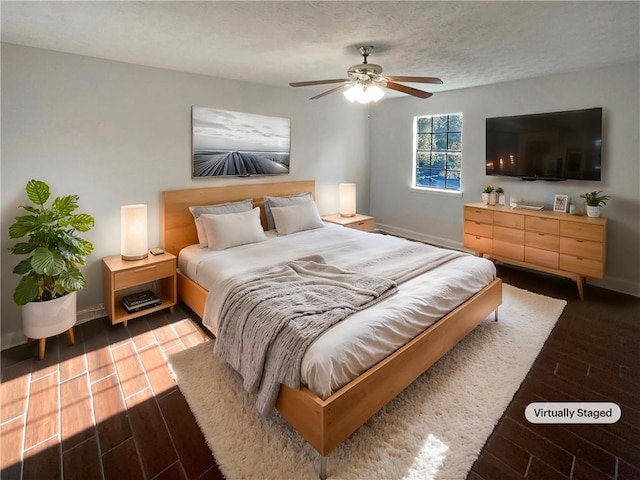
[102,252,178,326]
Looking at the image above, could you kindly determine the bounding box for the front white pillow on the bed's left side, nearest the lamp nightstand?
[200,207,267,250]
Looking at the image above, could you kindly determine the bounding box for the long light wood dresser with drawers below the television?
[463,203,607,299]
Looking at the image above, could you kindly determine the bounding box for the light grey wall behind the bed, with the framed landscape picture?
[0,44,369,348]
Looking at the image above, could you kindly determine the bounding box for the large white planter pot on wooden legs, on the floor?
[22,292,77,339]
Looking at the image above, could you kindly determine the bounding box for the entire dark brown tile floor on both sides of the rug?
[0,266,640,480]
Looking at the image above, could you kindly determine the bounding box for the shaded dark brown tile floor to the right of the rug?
[467,266,640,480]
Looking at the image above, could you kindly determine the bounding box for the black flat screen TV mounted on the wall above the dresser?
[486,108,602,181]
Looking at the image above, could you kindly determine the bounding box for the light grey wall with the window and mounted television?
[370,63,640,296]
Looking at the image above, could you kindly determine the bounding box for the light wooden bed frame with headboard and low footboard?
[162,181,502,478]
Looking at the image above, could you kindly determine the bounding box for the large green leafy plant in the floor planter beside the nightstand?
[9,180,94,305]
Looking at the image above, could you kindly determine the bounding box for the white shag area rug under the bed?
[169,284,566,480]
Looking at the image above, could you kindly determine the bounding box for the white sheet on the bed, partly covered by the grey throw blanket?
[178,224,496,398]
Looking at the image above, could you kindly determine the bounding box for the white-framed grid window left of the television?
[414,113,462,192]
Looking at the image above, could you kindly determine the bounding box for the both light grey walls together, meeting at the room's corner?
[0,44,640,348]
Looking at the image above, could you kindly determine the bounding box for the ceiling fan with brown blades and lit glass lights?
[289,46,442,103]
